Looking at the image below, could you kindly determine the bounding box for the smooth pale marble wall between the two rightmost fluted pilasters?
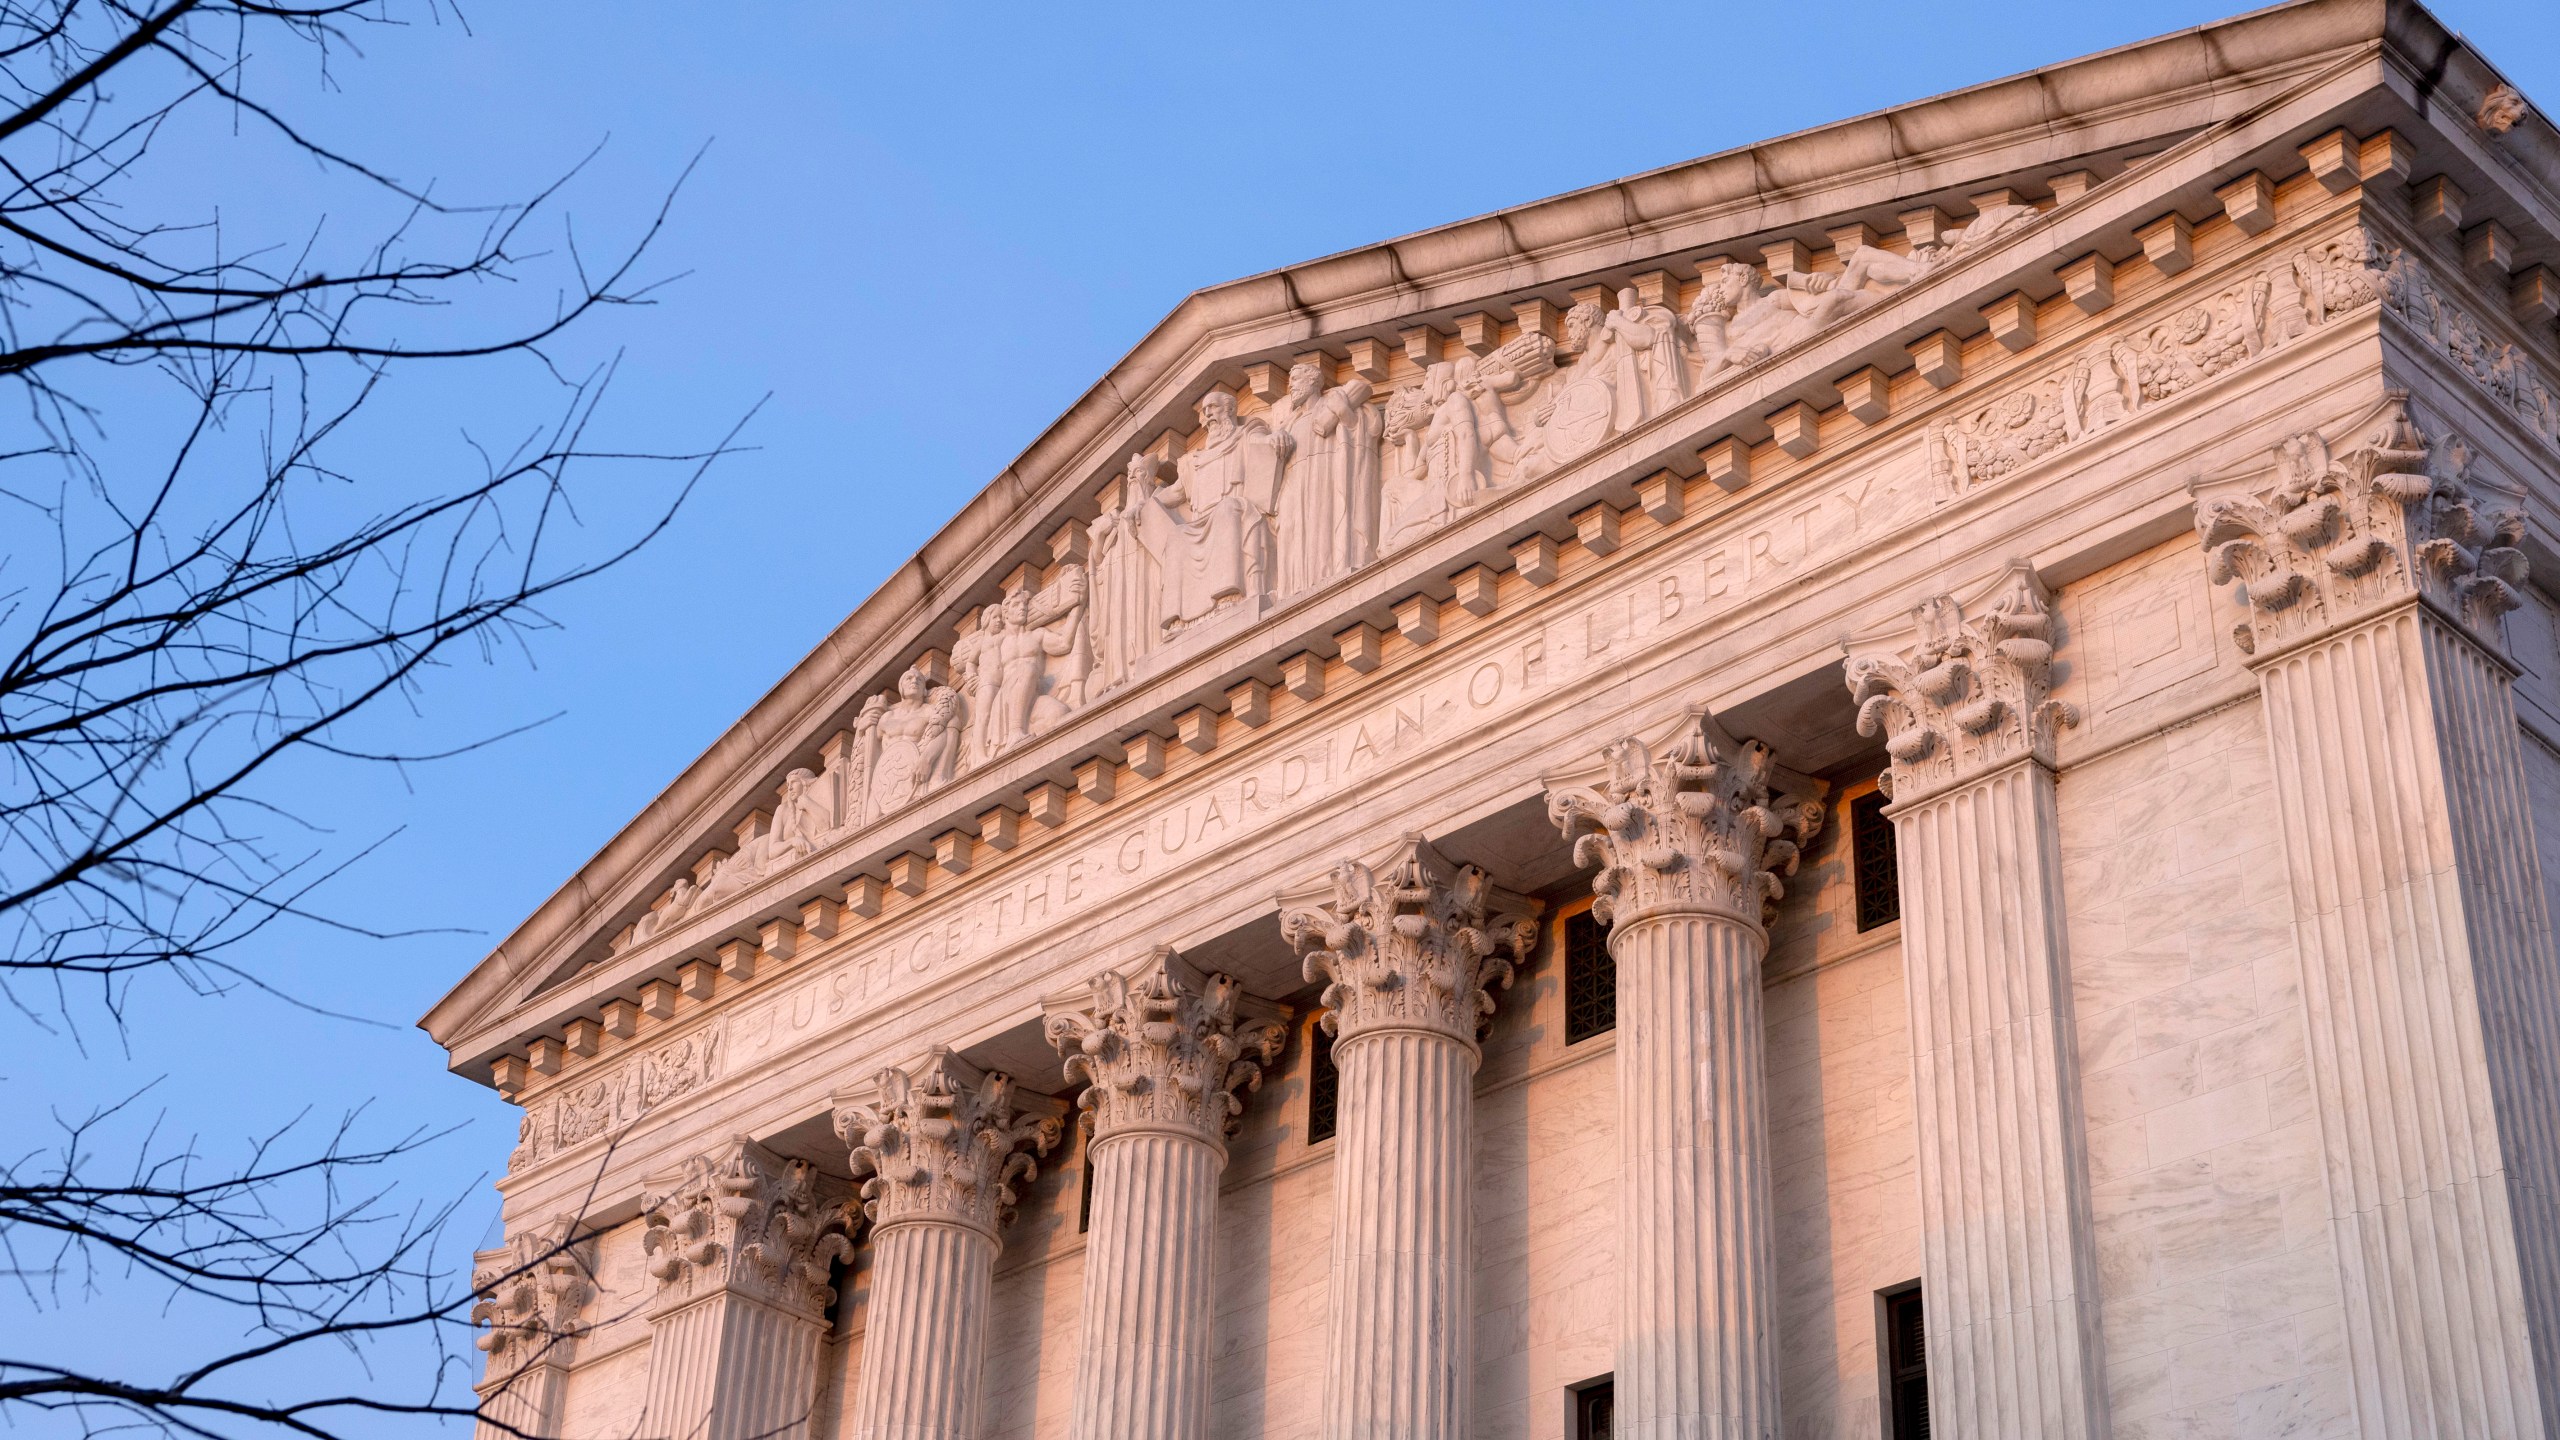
[2061,541,2353,1440]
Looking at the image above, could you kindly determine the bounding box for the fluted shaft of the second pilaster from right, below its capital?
[1894,758,2107,1440]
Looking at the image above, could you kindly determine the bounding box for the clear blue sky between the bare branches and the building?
[0,0,2560,1414]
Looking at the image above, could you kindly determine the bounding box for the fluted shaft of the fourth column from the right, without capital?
[1324,1030,1477,1440]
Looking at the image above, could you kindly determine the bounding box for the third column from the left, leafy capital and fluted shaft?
[835,1048,1068,1440]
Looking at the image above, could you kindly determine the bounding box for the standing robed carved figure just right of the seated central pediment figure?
[1270,361,1380,594]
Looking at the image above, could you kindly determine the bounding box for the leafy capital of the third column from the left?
[835,1045,1068,1235]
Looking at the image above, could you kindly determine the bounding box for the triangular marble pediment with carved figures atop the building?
[428,3,2547,1086]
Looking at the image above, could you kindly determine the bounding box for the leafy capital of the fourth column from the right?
[1280,835,1546,1051]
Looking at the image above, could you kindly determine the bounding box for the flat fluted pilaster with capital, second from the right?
[1848,566,2107,1440]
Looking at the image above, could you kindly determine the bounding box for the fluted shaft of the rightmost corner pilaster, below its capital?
[2258,602,2560,1440]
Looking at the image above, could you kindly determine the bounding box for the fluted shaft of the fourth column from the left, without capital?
[1073,1130,1226,1440]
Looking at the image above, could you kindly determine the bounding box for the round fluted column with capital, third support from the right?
[1546,717,1823,1440]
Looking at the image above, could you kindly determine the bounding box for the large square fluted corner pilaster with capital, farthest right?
[2196,392,2560,1437]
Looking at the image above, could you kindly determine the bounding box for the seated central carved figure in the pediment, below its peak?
[1137,389,1290,633]
